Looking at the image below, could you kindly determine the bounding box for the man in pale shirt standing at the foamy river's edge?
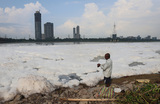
[97,53,112,87]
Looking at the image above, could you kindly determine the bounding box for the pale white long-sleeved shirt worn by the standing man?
[100,59,112,77]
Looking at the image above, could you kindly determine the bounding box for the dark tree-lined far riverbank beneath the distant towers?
[0,37,160,43]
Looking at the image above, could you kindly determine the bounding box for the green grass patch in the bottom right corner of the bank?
[117,83,160,104]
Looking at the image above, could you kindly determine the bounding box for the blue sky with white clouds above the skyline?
[0,0,160,39]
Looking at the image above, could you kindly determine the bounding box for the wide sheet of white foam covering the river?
[0,42,160,100]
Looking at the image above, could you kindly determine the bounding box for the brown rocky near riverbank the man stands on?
[2,73,160,104]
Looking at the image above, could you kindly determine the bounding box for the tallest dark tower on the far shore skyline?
[34,11,42,40]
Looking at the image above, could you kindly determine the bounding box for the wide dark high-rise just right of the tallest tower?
[44,22,54,39]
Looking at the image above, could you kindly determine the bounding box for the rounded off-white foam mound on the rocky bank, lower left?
[17,75,54,97]
